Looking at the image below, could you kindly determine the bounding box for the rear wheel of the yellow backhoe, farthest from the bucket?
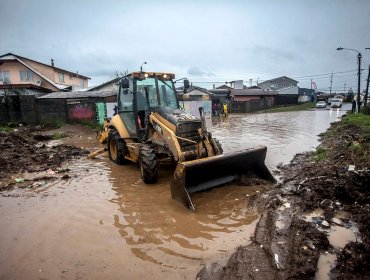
[108,129,129,165]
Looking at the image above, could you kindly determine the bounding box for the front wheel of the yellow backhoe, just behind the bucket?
[139,144,158,184]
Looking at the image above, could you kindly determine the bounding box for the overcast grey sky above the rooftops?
[0,0,370,91]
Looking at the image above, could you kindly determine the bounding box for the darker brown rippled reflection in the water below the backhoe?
[110,164,260,267]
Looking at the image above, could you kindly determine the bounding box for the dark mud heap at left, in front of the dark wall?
[0,128,88,190]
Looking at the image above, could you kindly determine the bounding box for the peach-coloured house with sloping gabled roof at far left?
[0,53,90,96]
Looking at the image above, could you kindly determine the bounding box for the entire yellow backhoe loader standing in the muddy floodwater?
[94,71,274,210]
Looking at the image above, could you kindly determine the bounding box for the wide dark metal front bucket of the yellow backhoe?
[171,146,275,211]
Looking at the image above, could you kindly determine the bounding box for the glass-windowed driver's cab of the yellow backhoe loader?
[118,72,179,141]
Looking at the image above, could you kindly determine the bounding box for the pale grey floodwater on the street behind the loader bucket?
[213,104,349,169]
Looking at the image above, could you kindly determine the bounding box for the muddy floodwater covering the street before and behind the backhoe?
[0,104,344,279]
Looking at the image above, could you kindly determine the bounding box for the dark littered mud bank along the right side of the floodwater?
[197,114,370,279]
